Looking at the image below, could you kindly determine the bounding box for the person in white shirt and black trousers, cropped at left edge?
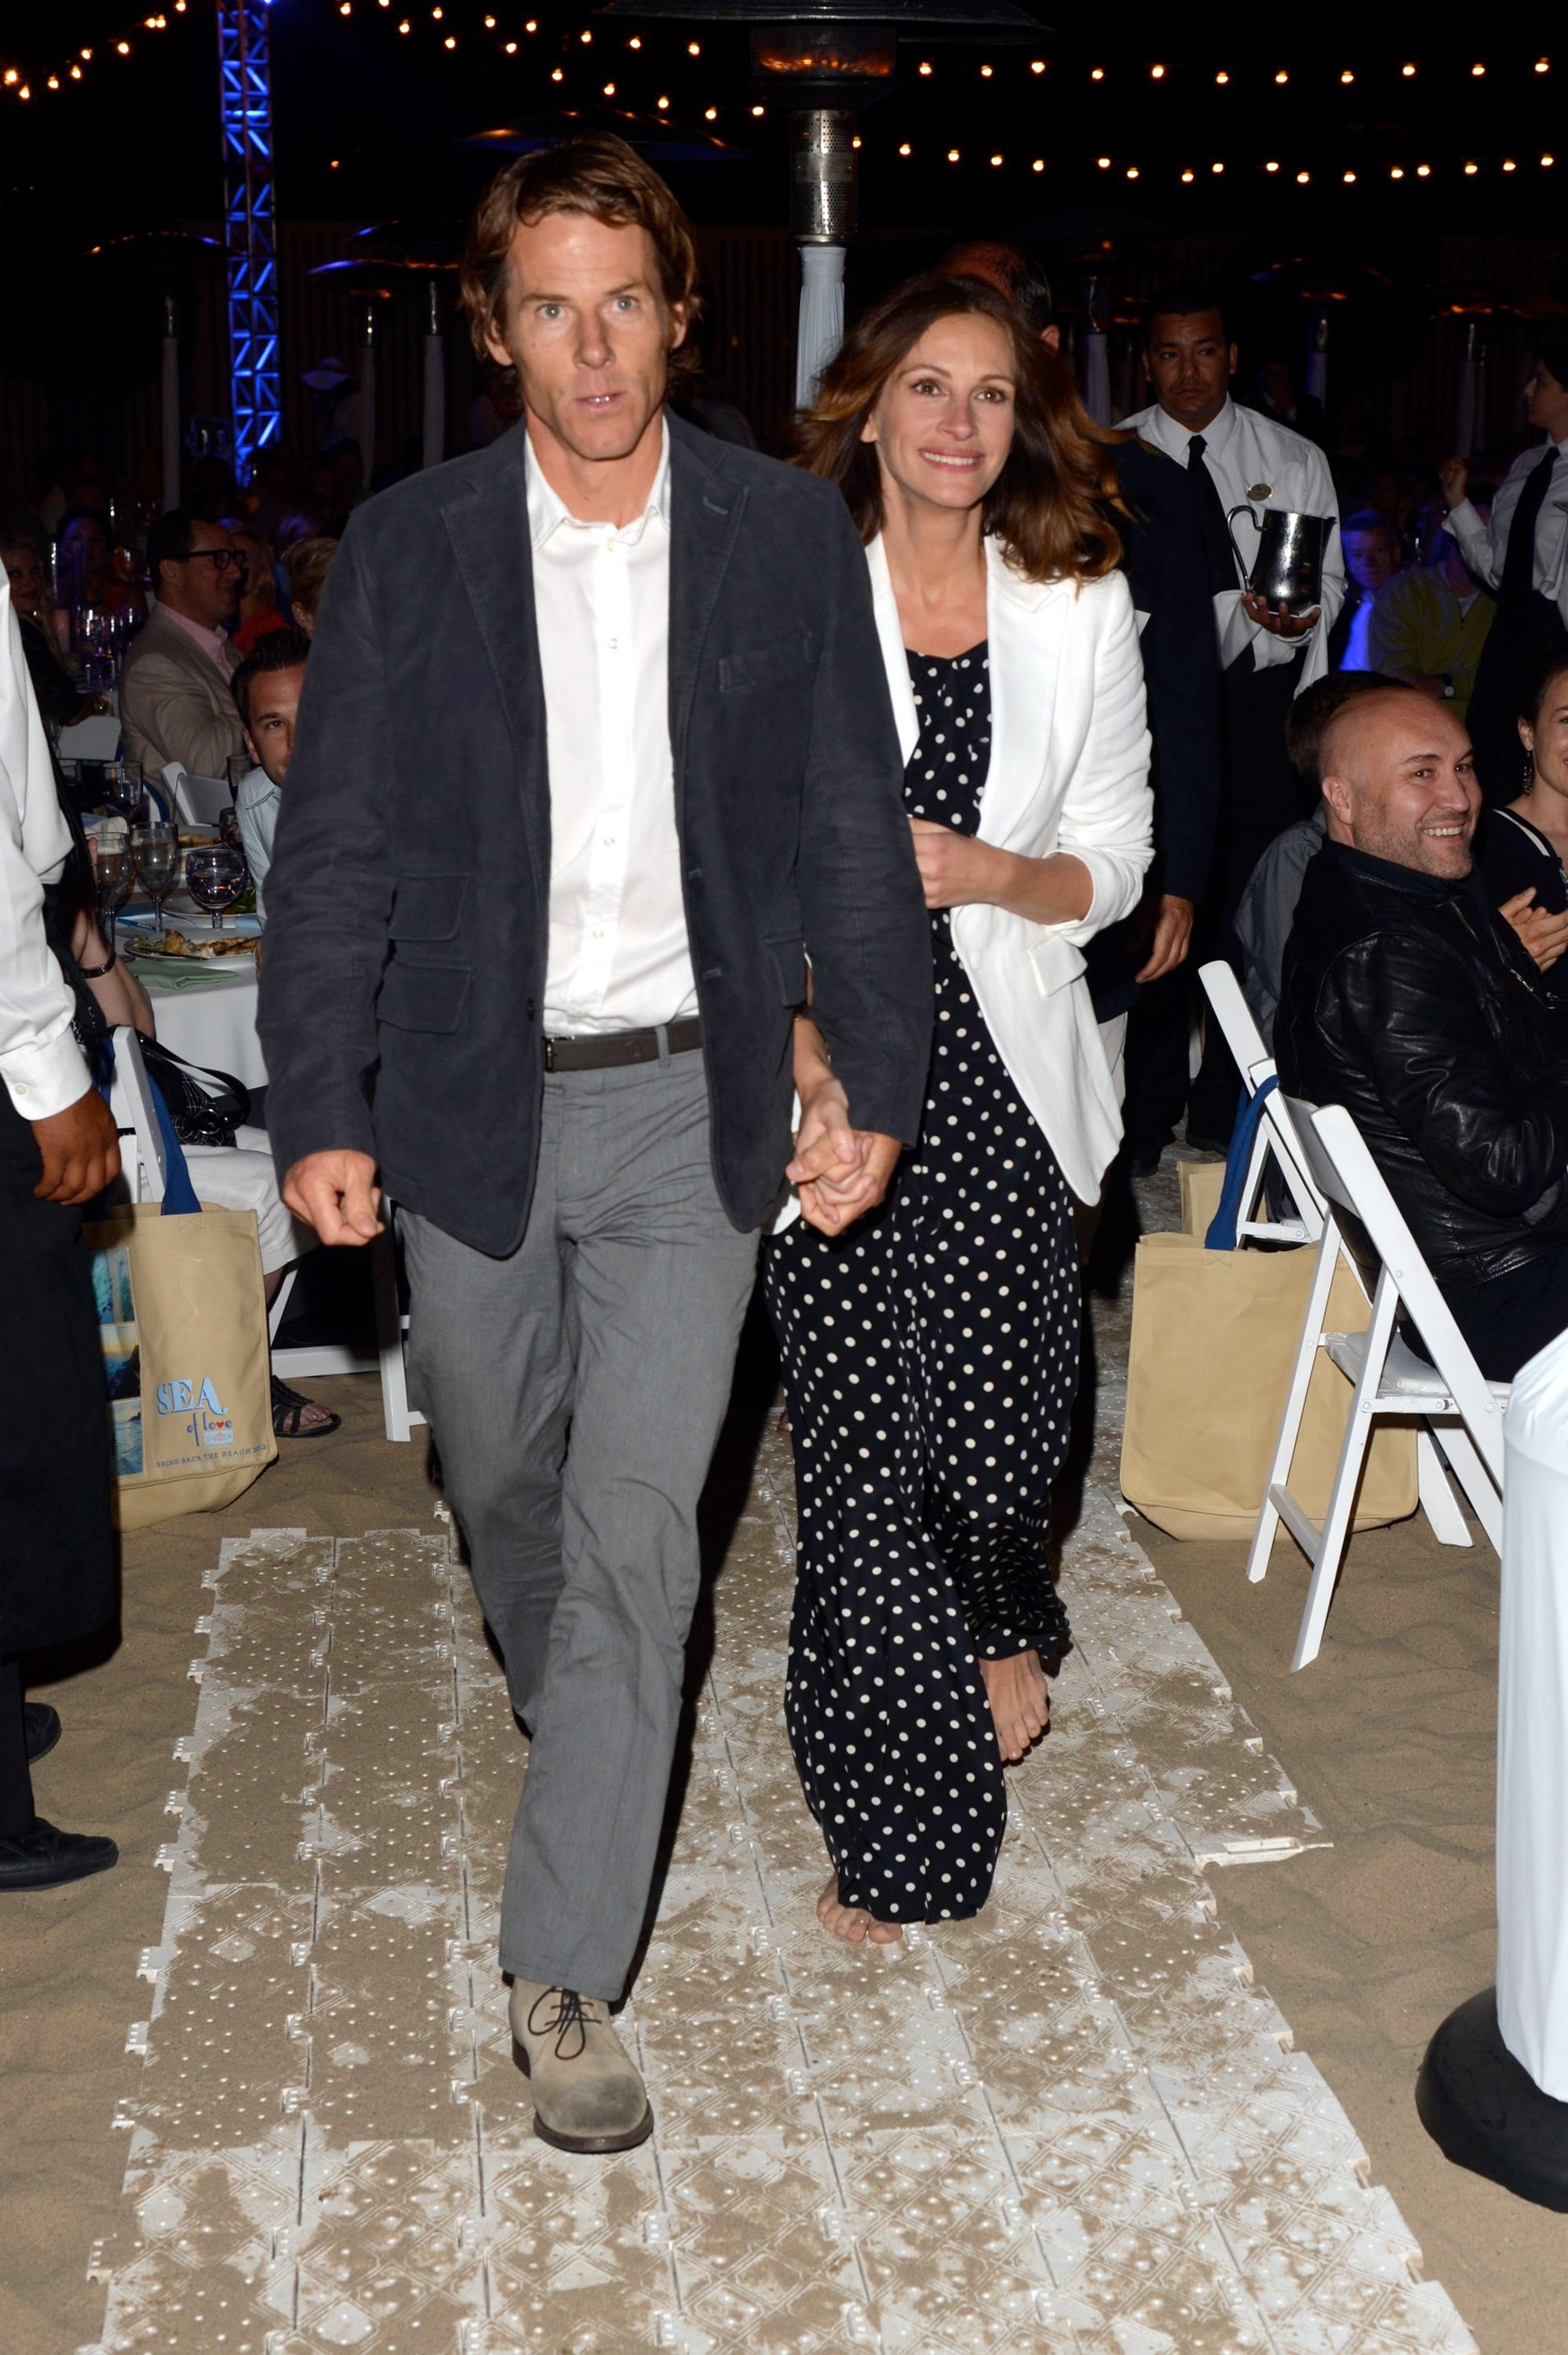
[0,598,120,1893]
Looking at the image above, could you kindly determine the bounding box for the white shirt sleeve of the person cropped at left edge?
[0,598,87,1121]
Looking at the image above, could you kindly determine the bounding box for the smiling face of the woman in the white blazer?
[862,311,1017,509]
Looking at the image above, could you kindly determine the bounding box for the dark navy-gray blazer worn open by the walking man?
[259,417,930,1255]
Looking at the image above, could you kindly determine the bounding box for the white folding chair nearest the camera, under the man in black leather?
[1248,1100,1509,1670]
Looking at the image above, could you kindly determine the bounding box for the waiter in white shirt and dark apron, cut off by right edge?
[1441,318,1568,801]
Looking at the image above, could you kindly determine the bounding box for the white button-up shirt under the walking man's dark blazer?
[527,426,697,1034]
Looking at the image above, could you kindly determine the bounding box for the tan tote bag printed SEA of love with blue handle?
[82,1064,278,1531]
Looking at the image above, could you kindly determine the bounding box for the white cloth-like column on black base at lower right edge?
[1497,1333,1568,2101]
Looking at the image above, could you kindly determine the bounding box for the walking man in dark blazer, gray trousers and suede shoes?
[261,137,930,2150]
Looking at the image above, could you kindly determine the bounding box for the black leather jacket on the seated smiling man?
[1274,843,1568,1295]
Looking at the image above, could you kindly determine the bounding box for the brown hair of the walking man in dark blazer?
[461,132,702,374]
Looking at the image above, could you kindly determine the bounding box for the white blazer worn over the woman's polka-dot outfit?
[866,537,1154,1201]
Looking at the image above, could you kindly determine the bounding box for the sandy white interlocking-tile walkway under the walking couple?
[92,1439,1474,2355]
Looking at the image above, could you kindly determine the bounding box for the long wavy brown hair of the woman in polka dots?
[796,271,1121,582]
